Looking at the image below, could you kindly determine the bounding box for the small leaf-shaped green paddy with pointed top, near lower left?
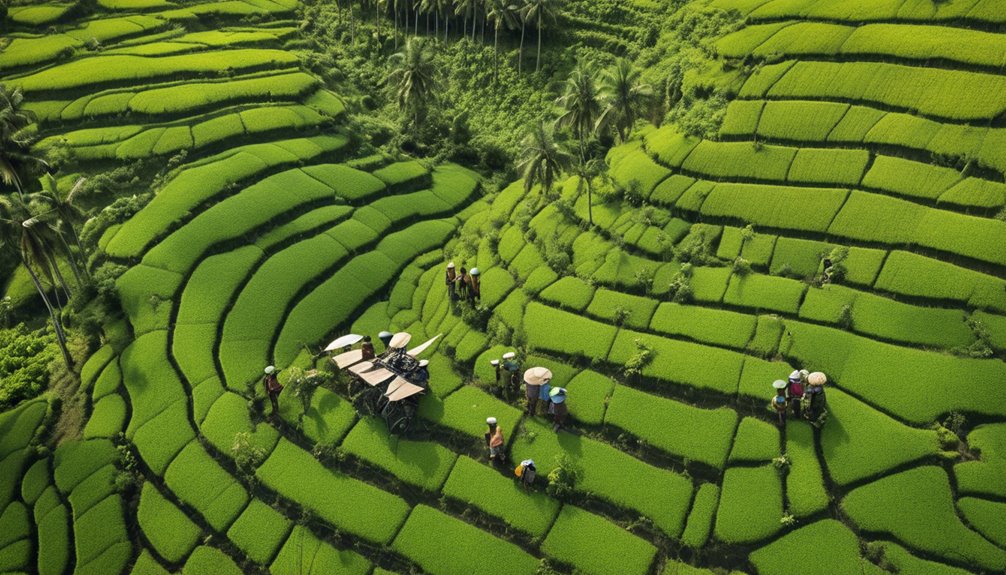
[137,483,202,563]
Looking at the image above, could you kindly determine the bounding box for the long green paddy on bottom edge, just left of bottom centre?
[392,505,538,575]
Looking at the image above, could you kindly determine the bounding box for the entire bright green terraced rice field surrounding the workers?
[0,0,1006,575]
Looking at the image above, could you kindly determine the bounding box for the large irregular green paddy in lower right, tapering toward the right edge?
[842,466,1006,571]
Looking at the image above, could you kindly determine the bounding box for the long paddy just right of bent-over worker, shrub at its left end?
[512,419,692,537]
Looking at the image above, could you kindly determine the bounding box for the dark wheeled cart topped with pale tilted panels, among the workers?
[325,332,440,434]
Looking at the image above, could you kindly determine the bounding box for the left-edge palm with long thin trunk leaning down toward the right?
[0,196,73,370]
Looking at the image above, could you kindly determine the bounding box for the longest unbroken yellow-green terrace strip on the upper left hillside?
[13,48,297,92]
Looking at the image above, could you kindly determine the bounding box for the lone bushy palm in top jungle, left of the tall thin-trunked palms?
[384,37,437,129]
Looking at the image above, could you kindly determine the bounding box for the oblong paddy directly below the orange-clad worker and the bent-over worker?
[443,455,561,537]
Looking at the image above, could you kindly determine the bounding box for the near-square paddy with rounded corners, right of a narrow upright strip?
[715,464,783,544]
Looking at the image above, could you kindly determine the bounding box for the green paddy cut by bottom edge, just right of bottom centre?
[541,505,657,575]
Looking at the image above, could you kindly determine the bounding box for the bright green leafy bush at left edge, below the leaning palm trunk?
[0,324,57,409]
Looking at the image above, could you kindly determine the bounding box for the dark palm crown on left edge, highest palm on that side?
[0,83,48,197]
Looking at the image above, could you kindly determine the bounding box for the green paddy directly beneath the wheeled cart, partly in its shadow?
[341,417,458,492]
